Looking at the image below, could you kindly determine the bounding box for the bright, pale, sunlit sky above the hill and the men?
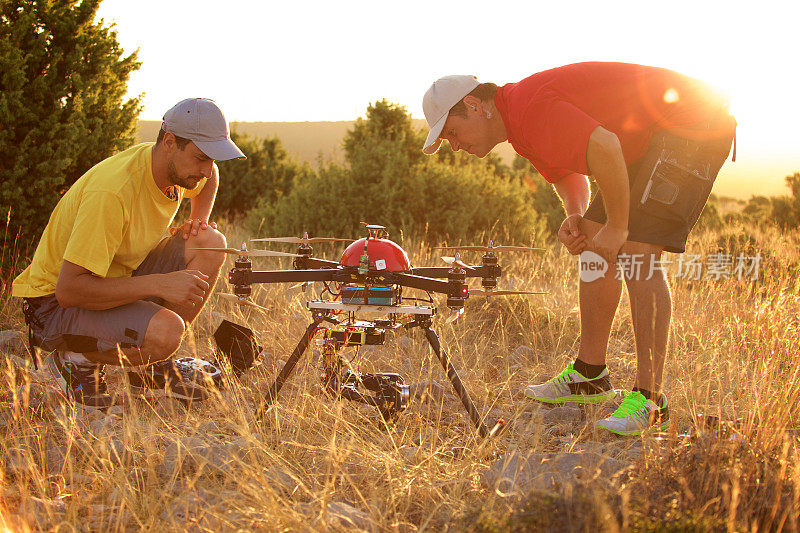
[98,0,800,196]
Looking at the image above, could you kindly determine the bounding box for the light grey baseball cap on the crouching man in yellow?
[161,98,246,161]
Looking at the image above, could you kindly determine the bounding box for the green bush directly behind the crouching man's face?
[214,132,311,217]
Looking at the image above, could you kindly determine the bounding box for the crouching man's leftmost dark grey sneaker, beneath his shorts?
[47,351,114,411]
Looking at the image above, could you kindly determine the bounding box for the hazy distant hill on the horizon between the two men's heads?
[137,119,514,168]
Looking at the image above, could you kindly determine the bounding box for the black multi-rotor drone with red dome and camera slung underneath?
[199,224,542,437]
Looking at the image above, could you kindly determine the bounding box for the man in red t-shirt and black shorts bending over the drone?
[423,63,736,434]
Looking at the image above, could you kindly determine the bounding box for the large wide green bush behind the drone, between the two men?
[248,100,539,242]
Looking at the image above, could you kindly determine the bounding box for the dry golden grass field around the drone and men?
[0,219,800,532]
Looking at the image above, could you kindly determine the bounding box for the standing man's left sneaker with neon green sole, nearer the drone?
[525,363,616,403]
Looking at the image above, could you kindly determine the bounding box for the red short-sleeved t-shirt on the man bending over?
[494,62,727,183]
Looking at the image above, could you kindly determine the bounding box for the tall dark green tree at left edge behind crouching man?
[0,0,140,240]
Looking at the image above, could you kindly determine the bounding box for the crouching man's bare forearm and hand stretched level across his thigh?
[56,261,209,311]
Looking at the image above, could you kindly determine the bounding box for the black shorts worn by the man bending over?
[584,117,736,253]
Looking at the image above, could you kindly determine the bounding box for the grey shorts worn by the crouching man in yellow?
[26,233,186,353]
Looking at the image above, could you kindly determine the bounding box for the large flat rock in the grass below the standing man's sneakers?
[483,451,629,494]
